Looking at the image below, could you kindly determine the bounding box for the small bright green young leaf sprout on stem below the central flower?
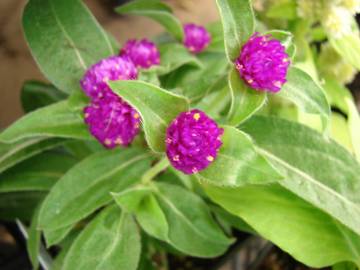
[113,186,169,241]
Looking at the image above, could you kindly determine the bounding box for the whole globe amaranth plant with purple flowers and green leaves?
[0,0,360,270]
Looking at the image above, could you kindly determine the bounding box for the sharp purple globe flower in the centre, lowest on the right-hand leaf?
[166,110,224,174]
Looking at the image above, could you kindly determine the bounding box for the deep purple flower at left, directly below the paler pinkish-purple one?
[84,92,140,148]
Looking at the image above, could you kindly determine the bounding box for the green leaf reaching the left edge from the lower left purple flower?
[0,101,92,143]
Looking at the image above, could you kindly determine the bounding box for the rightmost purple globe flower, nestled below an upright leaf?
[235,33,290,92]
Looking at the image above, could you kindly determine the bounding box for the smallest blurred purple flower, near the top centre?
[184,23,211,53]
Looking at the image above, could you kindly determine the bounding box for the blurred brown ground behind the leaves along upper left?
[0,0,218,129]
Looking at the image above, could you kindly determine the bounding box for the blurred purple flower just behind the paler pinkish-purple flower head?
[120,39,160,68]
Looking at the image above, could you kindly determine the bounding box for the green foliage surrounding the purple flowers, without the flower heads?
[0,0,360,270]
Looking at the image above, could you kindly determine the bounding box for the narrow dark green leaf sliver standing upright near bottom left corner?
[26,209,41,269]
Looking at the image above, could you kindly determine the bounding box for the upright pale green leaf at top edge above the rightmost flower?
[216,0,255,62]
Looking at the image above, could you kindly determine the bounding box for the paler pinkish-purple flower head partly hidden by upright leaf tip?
[80,56,138,98]
